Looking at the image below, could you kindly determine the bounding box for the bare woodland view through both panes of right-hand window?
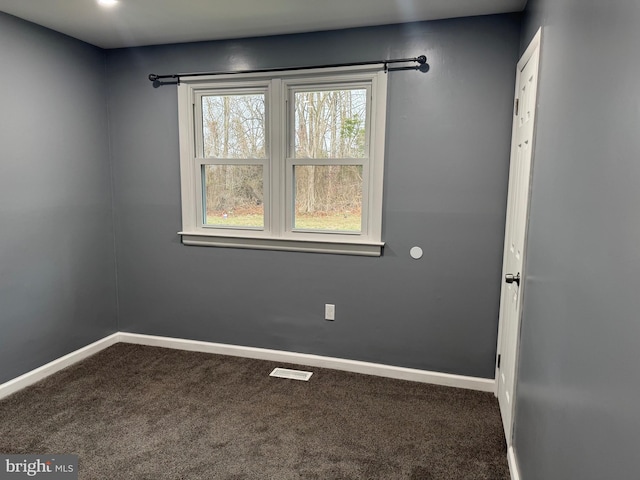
[294,89,367,232]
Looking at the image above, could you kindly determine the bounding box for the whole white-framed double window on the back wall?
[178,65,387,256]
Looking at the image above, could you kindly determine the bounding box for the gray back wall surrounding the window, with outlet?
[107,16,520,377]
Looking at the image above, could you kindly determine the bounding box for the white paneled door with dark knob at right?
[496,31,541,445]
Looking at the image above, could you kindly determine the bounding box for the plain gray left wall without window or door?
[0,13,117,383]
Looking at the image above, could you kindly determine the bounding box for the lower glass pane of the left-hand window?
[202,165,264,227]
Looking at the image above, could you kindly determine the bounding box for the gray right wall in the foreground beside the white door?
[515,0,640,480]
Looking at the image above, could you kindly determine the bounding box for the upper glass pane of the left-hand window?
[202,94,265,158]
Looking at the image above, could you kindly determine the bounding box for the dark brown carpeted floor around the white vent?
[0,344,509,480]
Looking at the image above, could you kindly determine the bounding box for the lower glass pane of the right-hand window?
[293,165,362,232]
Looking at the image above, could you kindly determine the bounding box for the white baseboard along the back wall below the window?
[120,332,495,392]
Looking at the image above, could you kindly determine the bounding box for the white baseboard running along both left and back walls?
[0,332,495,399]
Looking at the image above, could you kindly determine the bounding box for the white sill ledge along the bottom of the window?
[178,232,384,257]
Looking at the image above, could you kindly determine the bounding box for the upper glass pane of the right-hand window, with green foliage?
[294,89,367,158]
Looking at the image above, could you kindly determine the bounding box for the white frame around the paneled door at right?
[495,27,542,448]
